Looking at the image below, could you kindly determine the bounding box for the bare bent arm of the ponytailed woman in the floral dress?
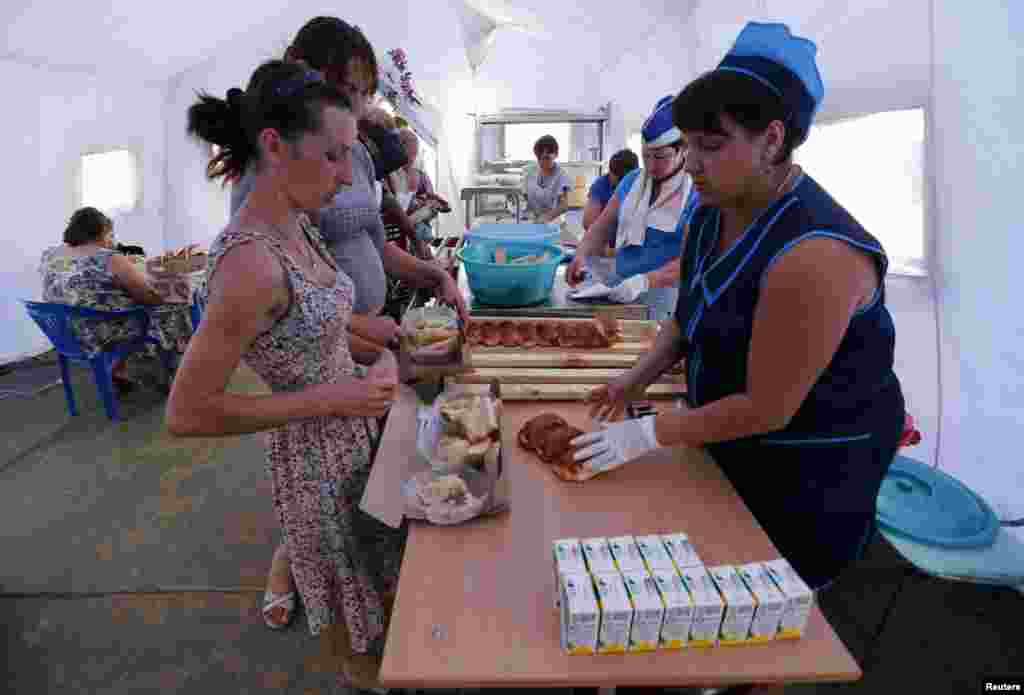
[165,243,394,436]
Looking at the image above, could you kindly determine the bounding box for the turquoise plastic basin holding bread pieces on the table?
[456,242,563,306]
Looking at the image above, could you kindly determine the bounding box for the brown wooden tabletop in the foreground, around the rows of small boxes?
[371,388,861,688]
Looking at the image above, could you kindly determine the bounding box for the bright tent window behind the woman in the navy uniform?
[795,108,926,274]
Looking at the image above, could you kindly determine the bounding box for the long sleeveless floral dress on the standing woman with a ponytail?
[199,222,406,653]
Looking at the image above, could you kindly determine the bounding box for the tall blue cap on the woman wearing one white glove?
[717,21,825,137]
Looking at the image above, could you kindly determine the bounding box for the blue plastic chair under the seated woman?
[22,300,172,421]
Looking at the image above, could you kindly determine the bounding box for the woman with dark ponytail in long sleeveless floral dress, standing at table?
[167,60,403,687]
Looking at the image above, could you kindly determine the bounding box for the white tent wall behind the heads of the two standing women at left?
[165,2,472,247]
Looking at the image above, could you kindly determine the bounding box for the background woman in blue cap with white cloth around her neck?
[566,96,693,320]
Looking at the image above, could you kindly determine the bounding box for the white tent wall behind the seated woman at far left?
[0,60,164,364]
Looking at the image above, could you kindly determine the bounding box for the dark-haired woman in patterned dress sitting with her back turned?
[39,208,191,391]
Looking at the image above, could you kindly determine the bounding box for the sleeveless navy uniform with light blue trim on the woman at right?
[676,175,904,585]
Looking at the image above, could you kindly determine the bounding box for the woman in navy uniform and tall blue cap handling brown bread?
[573,23,904,589]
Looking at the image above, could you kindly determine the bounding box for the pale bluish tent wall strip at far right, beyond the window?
[933,0,1024,522]
